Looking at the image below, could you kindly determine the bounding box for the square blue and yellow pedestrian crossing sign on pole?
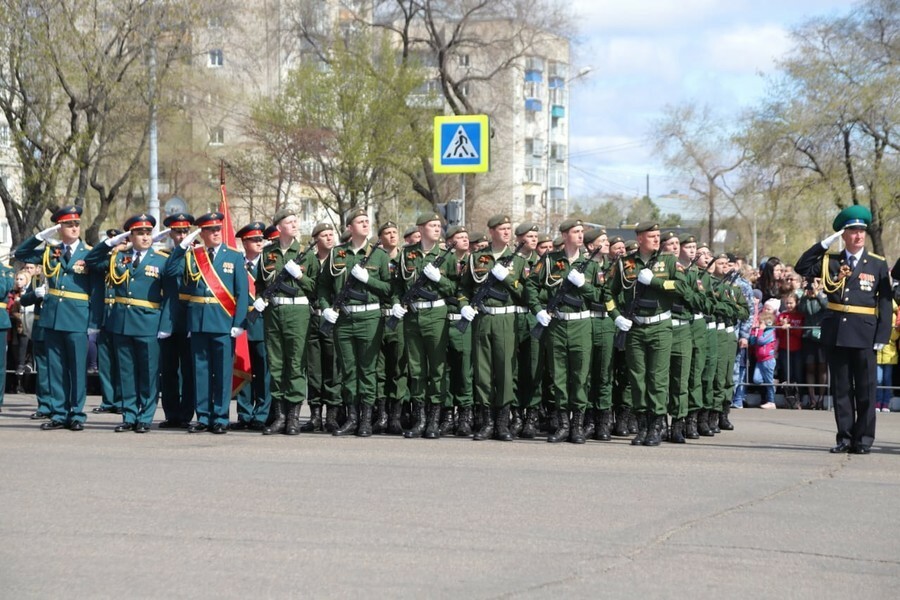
[434,115,490,173]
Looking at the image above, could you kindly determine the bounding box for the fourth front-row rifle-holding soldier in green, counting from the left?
[459,215,525,441]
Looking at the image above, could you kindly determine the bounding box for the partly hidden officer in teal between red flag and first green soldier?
[229,221,272,431]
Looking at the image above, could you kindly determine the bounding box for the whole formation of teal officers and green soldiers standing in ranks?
[7,206,749,446]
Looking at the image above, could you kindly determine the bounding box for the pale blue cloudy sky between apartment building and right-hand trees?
[569,0,856,202]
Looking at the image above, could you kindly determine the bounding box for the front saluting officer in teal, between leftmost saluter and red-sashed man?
[85,214,171,433]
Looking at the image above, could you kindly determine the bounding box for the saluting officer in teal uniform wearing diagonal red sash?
[165,212,250,434]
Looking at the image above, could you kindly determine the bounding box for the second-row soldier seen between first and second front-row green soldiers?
[306,222,341,433]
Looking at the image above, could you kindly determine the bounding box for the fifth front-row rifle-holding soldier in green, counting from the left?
[526,219,599,444]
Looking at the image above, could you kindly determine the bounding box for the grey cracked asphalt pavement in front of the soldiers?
[0,395,900,599]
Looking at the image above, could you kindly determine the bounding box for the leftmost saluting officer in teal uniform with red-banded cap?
[16,206,99,431]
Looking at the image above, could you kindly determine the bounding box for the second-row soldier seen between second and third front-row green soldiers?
[372,221,410,435]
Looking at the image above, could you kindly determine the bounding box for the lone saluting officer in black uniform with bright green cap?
[794,205,893,454]
